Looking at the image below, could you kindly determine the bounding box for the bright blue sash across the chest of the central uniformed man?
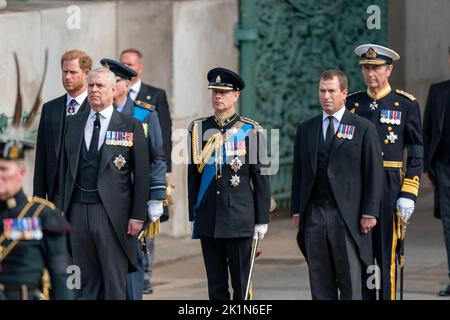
[192,123,252,239]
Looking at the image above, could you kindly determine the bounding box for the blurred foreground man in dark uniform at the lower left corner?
[0,110,73,300]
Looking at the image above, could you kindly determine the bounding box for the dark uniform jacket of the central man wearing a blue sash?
[188,114,270,238]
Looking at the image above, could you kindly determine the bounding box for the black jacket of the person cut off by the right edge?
[423,80,450,218]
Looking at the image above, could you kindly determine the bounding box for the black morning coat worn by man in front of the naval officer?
[291,110,383,265]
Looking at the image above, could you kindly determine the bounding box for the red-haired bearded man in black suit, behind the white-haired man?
[33,50,92,201]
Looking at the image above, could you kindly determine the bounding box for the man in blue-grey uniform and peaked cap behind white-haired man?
[100,59,166,300]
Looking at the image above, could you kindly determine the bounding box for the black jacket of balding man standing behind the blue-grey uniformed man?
[136,82,172,172]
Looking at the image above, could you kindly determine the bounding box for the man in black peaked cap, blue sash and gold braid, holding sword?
[188,68,270,300]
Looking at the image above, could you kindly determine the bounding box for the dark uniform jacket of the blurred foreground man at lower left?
[0,190,73,300]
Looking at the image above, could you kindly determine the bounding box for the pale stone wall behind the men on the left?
[0,0,239,236]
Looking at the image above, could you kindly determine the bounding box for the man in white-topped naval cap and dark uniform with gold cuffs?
[346,44,423,300]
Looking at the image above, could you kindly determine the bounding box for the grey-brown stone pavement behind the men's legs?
[144,188,448,300]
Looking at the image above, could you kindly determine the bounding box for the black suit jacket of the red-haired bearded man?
[33,94,89,201]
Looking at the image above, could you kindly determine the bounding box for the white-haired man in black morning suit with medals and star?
[58,68,149,299]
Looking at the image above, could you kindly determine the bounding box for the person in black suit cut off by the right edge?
[423,48,450,296]
